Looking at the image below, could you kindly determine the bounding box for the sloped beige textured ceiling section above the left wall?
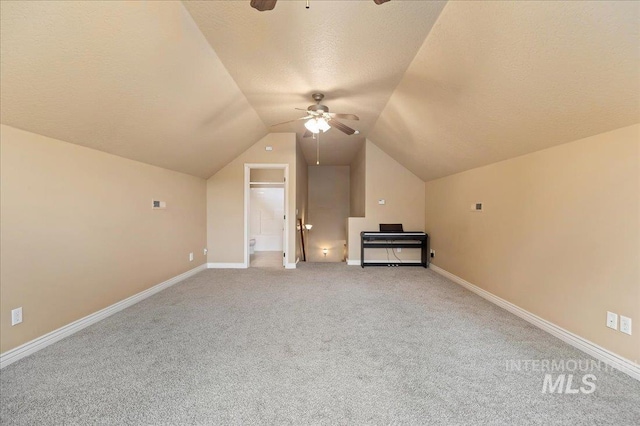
[0,1,267,177]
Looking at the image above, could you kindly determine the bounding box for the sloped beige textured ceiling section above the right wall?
[370,1,640,181]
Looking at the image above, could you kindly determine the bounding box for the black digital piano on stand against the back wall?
[360,231,429,268]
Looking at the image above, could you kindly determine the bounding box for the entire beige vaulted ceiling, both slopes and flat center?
[0,0,640,180]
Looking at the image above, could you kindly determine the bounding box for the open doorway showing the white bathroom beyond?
[245,164,287,268]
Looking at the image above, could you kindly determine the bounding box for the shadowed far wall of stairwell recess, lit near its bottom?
[307,166,349,262]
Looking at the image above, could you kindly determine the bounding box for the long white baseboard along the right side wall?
[429,264,640,380]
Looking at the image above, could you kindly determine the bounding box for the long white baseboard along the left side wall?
[0,263,206,369]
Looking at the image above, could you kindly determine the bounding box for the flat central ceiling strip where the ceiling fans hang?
[185,0,445,165]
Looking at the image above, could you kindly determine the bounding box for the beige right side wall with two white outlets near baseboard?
[426,125,640,363]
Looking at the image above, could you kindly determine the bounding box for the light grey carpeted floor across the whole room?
[0,263,640,425]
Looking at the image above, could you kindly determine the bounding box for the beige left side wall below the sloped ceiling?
[0,125,206,352]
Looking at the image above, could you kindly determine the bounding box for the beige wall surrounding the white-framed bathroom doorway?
[207,133,297,264]
